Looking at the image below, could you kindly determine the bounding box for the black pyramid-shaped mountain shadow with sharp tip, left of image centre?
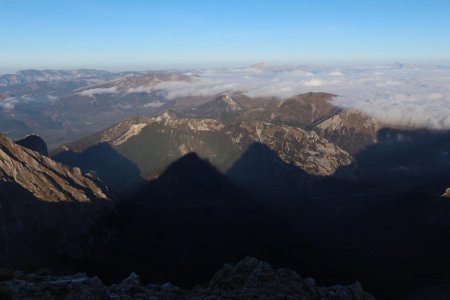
[92,153,324,286]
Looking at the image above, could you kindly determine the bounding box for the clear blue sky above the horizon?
[0,0,450,72]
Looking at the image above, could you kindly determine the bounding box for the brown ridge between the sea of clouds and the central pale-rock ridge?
[180,93,383,154]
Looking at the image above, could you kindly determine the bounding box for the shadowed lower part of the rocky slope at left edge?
[0,181,116,273]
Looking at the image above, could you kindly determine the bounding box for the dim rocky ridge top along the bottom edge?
[0,257,375,300]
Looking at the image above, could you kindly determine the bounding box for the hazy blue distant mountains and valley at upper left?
[0,70,194,147]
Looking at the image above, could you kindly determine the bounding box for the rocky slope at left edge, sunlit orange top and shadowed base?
[0,135,115,270]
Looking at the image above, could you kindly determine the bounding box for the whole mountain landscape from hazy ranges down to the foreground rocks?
[0,65,450,299]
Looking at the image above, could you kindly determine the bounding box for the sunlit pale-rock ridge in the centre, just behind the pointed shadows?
[54,106,352,195]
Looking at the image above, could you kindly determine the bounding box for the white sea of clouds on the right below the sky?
[154,64,450,129]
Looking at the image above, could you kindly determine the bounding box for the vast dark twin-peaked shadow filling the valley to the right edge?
[41,129,450,299]
